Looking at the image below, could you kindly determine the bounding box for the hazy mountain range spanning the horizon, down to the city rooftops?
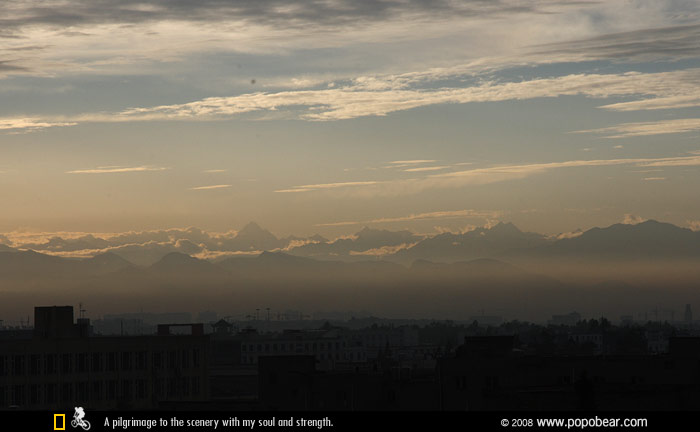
[0,221,700,319]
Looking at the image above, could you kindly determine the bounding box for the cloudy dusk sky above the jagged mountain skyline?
[0,0,700,236]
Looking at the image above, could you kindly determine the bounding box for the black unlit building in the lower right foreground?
[437,337,700,411]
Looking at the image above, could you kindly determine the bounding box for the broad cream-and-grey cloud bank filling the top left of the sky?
[0,0,581,78]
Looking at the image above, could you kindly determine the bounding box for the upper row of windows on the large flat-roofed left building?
[0,349,201,376]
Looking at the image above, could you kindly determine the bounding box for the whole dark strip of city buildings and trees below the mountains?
[0,306,700,411]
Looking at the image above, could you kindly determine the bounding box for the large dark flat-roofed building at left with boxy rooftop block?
[0,306,209,409]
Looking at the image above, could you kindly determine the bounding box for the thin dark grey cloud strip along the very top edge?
[0,0,540,31]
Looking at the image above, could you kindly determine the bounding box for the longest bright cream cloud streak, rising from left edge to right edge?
[0,64,700,131]
